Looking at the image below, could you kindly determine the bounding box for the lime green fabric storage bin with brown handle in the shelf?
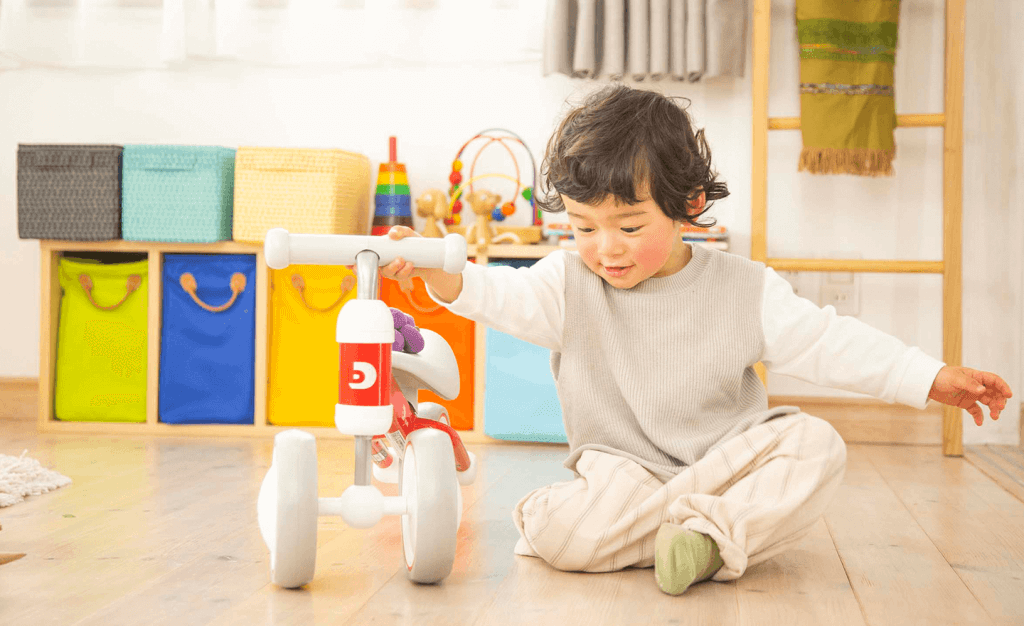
[53,257,150,422]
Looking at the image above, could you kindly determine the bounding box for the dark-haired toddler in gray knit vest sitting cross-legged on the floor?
[383,85,1011,594]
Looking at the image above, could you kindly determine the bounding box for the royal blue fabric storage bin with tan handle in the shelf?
[158,254,256,424]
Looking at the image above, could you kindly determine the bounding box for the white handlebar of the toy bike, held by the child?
[263,228,466,274]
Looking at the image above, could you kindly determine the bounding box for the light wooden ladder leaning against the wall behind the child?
[751,0,966,456]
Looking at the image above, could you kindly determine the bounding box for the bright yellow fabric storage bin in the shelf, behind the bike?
[267,265,355,428]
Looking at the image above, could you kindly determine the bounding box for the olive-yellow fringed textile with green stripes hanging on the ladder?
[797,0,900,176]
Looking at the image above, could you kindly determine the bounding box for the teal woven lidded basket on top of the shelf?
[121,145,234,243]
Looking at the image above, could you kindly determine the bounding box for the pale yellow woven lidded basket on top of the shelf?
[232,147,373,243]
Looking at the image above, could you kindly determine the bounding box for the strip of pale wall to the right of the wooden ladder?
[964,0,1024,450]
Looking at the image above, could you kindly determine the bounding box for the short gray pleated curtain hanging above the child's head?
[544,0,750,82]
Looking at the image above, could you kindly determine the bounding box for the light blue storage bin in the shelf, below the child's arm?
[483,259,568,444]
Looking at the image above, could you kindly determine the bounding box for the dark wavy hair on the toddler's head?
[537,84,729,227]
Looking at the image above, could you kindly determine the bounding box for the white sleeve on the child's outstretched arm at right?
[762,267,945,409]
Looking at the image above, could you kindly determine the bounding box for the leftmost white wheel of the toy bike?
[257,429,319,589]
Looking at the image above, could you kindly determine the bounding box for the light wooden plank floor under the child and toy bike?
[0,421,1024,626]
